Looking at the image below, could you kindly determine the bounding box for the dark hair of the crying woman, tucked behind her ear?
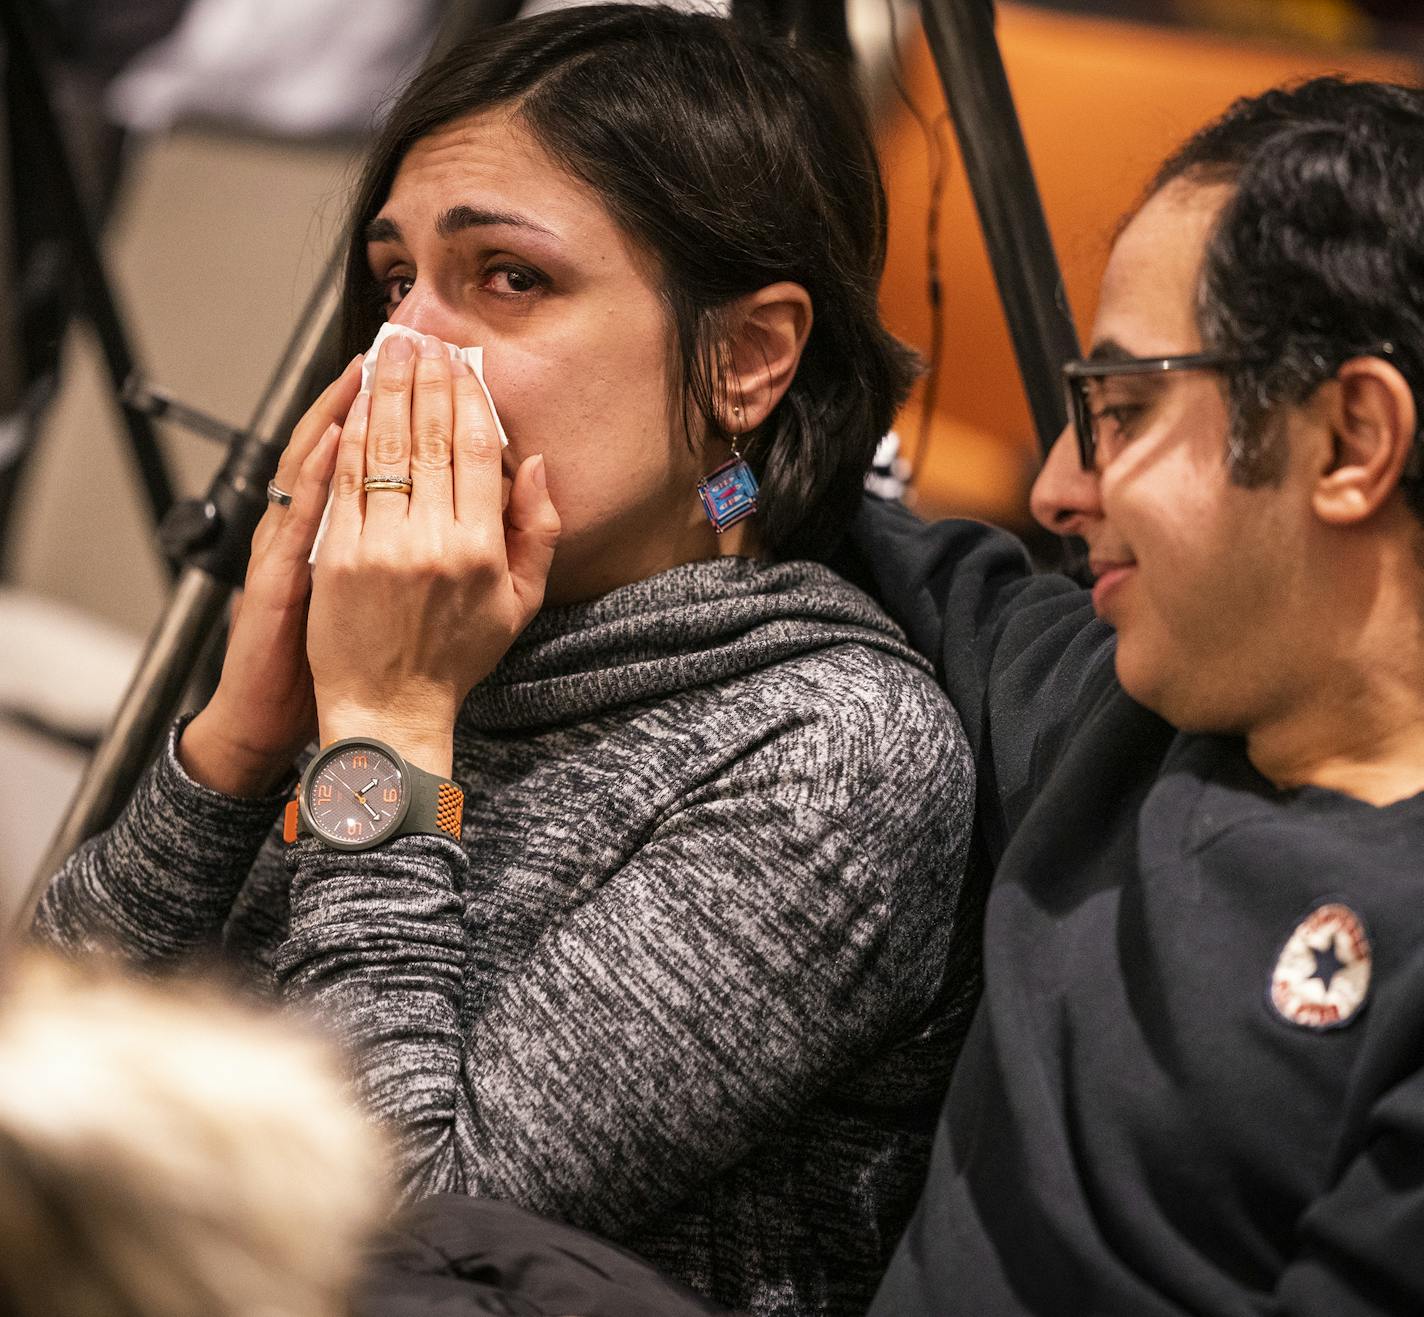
[334,4,914,558]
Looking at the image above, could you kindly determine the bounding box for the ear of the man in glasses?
[1312,357,1418,525]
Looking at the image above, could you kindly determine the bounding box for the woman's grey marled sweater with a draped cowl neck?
[37,558,974,1314]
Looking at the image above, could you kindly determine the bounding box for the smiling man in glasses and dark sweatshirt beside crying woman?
[859,80,1424,1317]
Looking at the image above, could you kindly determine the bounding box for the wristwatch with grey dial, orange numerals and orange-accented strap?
[282,736,464,850]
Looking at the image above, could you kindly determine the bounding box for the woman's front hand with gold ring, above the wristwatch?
[308,337,560,775]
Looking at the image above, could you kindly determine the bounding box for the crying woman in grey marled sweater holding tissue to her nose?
[38,6,973,1313]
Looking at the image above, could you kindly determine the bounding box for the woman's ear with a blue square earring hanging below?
[721,282,812,434]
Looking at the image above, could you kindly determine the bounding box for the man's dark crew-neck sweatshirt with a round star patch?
[856,501,1424,1317]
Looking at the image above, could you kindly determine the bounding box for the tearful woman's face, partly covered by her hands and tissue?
[366,110,742,604]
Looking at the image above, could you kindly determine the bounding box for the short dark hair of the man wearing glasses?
[1148,77,1424,520]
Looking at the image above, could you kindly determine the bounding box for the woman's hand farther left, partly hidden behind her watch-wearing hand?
[178,357,360,796]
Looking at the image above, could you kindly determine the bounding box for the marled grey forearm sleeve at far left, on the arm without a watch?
[31,719,286,965]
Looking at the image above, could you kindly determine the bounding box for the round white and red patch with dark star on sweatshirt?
[1270,903,1371,1029]
